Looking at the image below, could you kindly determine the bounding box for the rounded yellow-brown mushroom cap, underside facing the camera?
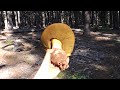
[41,23,75,56]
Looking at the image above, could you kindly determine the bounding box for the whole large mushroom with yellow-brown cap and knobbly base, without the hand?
[41,23,75,70]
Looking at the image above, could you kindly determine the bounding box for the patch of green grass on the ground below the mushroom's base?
[58,71,87,79]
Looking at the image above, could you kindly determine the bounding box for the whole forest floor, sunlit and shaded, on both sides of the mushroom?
[0,29,120,79]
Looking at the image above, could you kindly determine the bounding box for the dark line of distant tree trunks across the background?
[0,11,120,30]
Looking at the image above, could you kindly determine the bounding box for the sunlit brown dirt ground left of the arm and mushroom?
[0,33,45,79]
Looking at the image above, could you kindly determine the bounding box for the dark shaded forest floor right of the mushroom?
[59,30,120,79]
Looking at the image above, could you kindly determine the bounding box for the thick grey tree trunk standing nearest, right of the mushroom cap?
[83,11,91,36]
